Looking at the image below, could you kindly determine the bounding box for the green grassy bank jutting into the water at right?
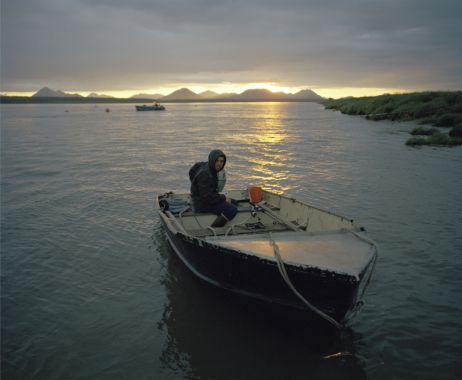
[323,91,462,146]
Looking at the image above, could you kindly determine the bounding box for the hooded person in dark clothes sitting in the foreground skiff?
[189,149,237,227]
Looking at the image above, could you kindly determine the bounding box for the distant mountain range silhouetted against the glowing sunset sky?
[28,87,324,102]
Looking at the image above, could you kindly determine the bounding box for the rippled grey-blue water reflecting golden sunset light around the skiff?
[1,103,462,380]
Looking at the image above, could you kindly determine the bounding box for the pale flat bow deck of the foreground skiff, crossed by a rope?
[206,231,375,278]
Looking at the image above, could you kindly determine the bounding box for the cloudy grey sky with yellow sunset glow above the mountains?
[0,0,462,97]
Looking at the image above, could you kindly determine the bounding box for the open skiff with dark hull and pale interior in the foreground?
[159,187,377,327]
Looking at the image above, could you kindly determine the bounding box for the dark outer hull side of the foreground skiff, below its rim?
[160,213,362,322]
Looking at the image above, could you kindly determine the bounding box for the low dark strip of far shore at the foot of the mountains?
[0,95,322,104]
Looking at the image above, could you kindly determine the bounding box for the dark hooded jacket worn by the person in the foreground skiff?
[189,150,226,212]
